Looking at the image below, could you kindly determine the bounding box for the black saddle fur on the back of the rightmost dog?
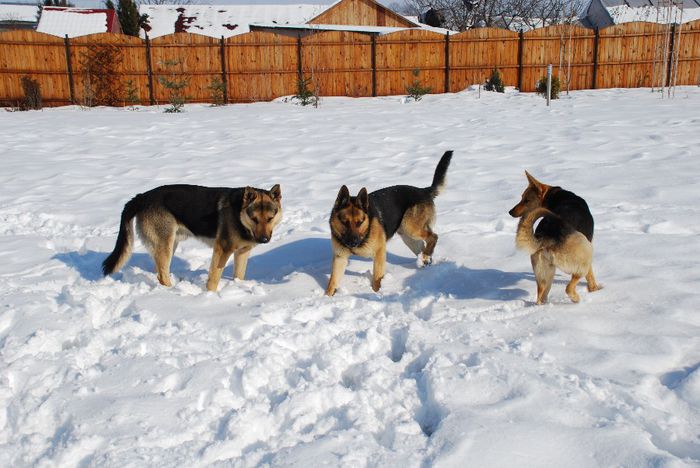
[535,187,593,242]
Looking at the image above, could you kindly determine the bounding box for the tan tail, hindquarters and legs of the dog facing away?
[515,208,595,304]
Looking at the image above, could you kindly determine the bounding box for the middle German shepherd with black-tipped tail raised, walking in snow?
[326,151,452,296]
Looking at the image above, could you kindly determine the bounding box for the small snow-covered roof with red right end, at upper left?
[36,7,119,37]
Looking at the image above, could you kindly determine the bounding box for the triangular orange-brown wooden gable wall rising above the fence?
[309,0,416,28]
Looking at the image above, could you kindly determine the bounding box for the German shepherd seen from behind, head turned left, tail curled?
[509,171,601,304]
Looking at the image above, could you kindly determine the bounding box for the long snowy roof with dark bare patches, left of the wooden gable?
[139,4,332,38]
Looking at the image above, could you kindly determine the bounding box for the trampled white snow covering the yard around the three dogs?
[0,87,700,467]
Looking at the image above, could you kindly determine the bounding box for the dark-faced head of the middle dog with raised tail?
[330,185,369,248]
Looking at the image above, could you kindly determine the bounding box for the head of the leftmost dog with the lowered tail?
[241,184,282,244]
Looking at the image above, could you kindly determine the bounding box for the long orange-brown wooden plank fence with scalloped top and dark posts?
[0,20,700,106]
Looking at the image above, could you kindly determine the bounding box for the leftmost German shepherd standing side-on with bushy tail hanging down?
[102,185,282,291]
